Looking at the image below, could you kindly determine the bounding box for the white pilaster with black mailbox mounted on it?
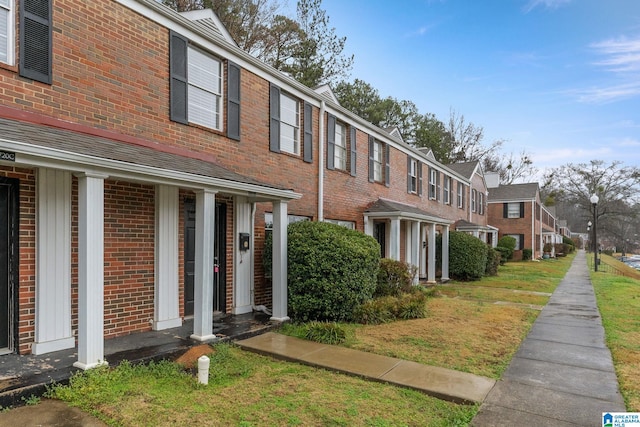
[231,196,253,314]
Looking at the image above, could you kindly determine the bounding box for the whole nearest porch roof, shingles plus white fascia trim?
[0,117,300,199]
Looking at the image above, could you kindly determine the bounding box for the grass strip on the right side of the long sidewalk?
[591,271,640,412]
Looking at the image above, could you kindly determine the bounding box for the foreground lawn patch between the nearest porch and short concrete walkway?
[49,344,477,426]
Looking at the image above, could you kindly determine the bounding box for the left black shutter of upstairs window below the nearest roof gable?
[169,31,189,125]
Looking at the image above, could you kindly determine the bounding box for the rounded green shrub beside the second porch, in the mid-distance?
[436,231,487,280]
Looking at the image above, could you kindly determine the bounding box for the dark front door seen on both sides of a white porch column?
[184,200,227,316]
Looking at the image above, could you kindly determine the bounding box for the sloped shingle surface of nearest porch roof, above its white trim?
[0,118,285,190]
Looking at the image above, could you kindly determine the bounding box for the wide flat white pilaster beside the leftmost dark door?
[31,168,76,354]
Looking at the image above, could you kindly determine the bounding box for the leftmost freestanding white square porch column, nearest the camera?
[73,173,107,369]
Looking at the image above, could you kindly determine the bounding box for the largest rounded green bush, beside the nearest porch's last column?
[265,221,380,321]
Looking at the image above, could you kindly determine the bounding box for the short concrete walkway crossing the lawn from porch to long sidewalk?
[236,332,495,403]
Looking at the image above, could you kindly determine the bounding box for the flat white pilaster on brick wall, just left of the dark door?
[153,185,182,331]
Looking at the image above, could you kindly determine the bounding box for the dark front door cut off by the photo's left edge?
[0,177,19,354]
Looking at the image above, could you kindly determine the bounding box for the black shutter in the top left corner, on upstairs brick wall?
[20,0,52,84]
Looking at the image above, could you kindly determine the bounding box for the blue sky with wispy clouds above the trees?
[304,0,640,179]
